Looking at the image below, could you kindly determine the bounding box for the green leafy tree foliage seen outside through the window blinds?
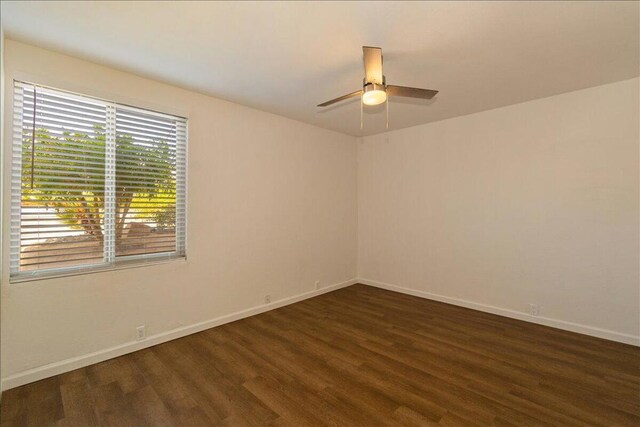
[22,126,176,246]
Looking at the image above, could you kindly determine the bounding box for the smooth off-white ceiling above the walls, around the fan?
[2,1,640,135]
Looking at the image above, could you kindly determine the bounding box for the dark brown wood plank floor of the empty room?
[1,285,640,426]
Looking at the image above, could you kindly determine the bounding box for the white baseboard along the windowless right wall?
[358,278,640,346]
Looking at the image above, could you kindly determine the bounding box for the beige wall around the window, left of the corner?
[1,40,357,386]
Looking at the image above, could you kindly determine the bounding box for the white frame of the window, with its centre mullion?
[7,79,189,283]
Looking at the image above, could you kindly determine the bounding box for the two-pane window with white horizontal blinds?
[10,82,187,281]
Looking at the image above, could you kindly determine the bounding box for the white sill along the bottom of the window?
[9,256,187,284]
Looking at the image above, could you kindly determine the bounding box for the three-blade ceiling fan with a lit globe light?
[318,46,438,107]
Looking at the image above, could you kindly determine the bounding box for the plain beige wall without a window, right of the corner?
[358,78,640,345]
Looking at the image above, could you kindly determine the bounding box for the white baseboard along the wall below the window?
[2,279,358,391]
